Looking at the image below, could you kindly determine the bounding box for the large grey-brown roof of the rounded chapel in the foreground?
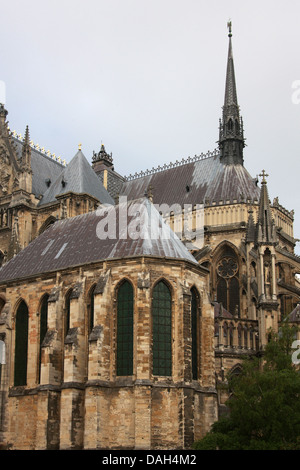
[0,198,198,283]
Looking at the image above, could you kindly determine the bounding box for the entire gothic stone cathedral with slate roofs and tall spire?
[0,28,300,450]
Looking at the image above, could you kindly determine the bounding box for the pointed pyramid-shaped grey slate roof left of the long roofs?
[39,150,114,206]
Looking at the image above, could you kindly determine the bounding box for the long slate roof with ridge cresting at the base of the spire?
[121,154,260,206]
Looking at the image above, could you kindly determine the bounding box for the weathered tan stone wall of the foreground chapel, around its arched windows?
[0,257,217,449]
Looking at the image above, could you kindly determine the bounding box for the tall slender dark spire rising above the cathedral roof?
[219,21,245,165]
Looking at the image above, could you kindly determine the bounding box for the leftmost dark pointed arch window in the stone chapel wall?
[14,300,28,386]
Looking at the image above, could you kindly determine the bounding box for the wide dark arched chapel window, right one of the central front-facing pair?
[152,281,172,376]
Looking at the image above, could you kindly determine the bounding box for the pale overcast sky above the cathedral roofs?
[0,0,300,254]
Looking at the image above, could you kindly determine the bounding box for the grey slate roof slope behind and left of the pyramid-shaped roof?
[13,138,64,196]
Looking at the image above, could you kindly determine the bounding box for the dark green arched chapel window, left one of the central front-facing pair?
[117,281,133,376]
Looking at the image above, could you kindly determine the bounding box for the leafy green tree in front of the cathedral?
[193,324,300,450]
